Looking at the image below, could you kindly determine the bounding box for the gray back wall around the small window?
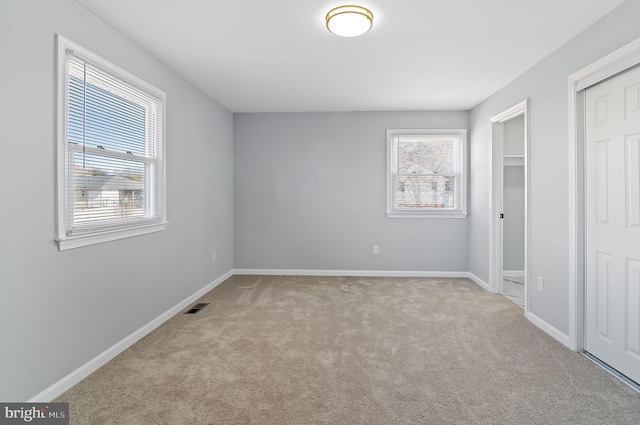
[234,112,468,271]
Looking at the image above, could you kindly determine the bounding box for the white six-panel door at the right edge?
[585,63,640,383]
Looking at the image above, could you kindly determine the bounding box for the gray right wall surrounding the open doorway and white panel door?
[469,0,640,334]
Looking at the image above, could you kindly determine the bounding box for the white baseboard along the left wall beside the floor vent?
[27,271,233,403]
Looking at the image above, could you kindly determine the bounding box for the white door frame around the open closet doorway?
[489,99,529,314]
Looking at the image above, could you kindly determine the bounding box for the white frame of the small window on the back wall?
[387,129,469,218]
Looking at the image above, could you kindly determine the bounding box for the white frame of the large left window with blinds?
[55,34,168,251]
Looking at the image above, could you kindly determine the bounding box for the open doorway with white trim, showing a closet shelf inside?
[489,100,528,312]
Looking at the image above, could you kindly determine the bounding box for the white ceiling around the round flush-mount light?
[77,0,624,112]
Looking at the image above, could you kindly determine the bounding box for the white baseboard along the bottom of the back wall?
[233,269,469,278]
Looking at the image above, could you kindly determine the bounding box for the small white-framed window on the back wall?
[387,130,467,218]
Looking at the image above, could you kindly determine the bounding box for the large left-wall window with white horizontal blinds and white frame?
[57,37,166,250]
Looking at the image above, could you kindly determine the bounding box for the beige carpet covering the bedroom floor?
[56,276,640,425]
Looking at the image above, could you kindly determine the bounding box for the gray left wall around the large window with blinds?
[0,0,233,401]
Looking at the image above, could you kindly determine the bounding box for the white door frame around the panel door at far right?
[568,38,640,351]
